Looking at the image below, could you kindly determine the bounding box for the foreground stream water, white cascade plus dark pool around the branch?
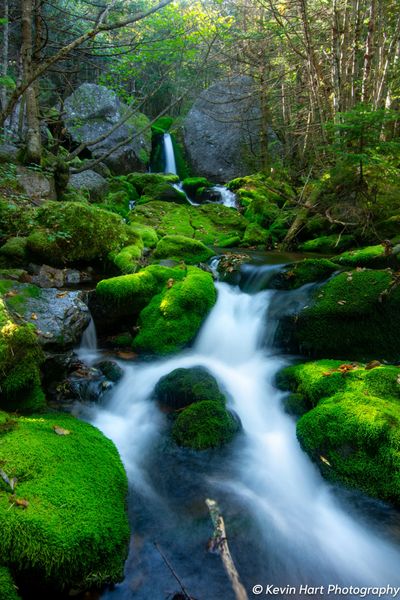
[91,274,400,600]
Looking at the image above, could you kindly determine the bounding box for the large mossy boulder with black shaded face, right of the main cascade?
[293,269,400,361]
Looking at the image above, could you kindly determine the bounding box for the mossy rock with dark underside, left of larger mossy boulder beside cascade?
[96,265,186,317]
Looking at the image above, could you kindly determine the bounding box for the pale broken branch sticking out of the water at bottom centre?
[206,498,248,600]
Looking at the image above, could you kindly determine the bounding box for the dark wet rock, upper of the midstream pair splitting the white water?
[154,367,225,410]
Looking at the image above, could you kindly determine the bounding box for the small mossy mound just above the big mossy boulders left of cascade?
[153,235,214,265]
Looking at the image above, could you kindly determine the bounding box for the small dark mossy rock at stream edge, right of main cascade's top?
[269,258,339,290]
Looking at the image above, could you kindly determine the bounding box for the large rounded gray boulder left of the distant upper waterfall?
[64,83,151,175]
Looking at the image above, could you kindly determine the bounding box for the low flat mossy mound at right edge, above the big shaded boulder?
[332,244,400,269]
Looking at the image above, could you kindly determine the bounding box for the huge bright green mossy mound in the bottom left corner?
[0,414,129,590]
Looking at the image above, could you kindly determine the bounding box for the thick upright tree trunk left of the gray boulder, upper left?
[21,0,42,164]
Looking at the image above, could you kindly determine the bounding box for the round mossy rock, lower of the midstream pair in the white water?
[172,400,240,450]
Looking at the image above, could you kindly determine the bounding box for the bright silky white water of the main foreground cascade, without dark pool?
[92,283,400,600]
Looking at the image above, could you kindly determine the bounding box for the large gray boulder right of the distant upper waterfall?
[184,76,280,181]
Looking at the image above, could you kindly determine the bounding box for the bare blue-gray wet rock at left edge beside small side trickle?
[0,281,90,349]
